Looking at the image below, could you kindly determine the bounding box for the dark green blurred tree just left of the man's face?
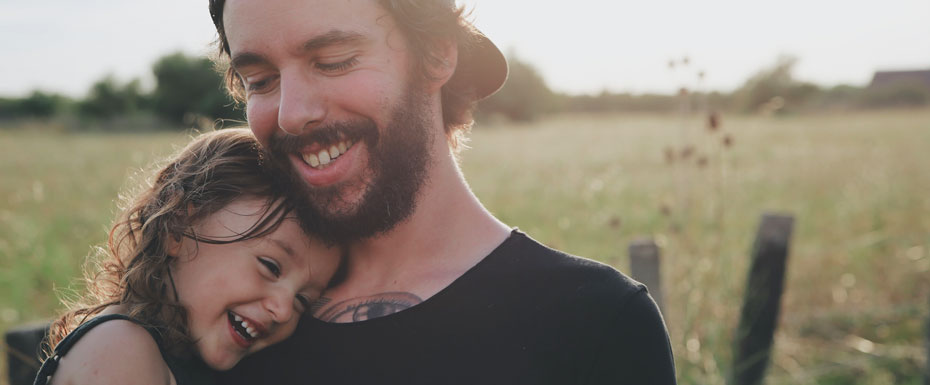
[152,52,243,123]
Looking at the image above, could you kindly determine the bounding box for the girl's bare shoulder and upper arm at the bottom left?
[50,318,174,385]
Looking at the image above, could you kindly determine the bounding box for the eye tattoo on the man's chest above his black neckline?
[312,292,423,323]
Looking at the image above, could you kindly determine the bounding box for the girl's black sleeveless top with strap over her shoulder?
[33,314,214,385]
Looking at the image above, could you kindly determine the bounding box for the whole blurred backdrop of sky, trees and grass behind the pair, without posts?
[0,0,930,385]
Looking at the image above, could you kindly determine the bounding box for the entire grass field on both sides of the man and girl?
[0,110,930,385]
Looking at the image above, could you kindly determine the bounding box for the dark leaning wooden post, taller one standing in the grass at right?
[727,213,794,385]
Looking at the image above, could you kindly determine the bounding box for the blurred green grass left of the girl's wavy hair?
[0,130,186,384]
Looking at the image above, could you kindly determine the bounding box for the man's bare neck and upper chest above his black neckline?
[314,144,510,322]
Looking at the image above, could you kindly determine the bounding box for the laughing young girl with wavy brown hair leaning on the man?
[35,129,340,385]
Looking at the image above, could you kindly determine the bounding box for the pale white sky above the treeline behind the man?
[0,0,930,97]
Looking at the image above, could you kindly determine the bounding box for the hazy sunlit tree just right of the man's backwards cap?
[478,53,555,121]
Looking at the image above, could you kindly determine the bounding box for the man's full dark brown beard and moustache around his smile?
[266,91,433,243]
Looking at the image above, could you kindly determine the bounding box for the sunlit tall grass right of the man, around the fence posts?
[464,110,930,384]
